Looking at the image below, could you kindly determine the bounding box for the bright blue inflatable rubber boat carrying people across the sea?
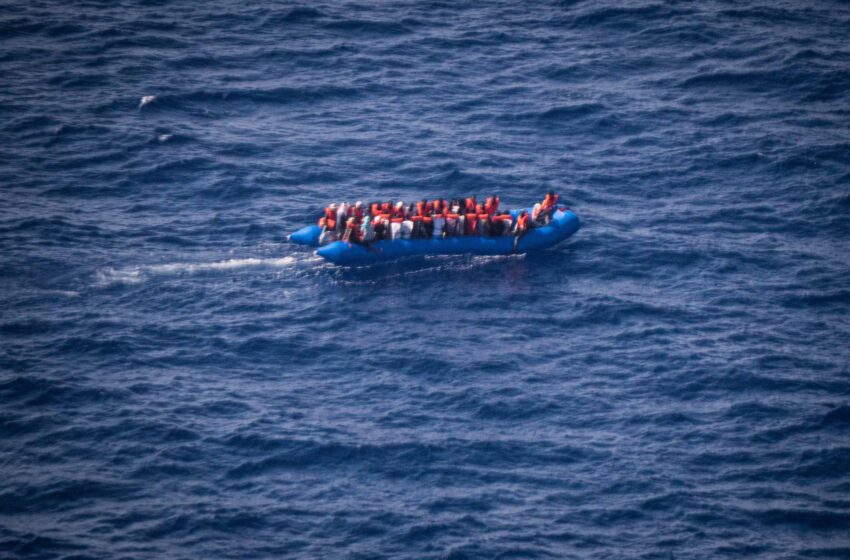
[289,209,581,266]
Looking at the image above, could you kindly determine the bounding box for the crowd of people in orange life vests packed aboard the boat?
[319,191,558,246]
